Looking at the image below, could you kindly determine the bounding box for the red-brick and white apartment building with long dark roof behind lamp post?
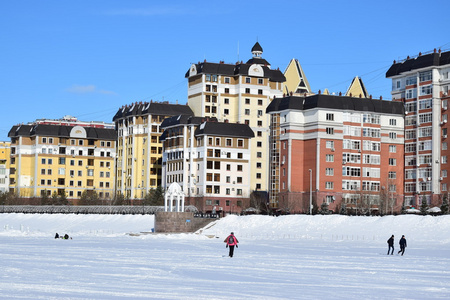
[266,94,404,214]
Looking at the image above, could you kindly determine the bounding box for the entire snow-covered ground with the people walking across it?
[0,214,450,299]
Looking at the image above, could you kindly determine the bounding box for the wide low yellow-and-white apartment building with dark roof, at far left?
[8,117,117,202]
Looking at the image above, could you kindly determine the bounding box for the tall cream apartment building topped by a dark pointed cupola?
[185,42,286,191]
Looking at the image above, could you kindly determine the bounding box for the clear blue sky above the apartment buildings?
[0,0,450,141]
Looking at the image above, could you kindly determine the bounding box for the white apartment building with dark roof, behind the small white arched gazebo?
[161,115,254,213]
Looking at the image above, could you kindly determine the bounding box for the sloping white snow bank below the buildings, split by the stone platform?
[0,214,450,244]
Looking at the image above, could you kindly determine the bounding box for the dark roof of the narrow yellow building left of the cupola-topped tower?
[113,102,194,121]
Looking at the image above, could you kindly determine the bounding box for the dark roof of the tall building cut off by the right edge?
[386,51,450,78]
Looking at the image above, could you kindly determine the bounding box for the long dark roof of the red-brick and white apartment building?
[266,94,405,115]
